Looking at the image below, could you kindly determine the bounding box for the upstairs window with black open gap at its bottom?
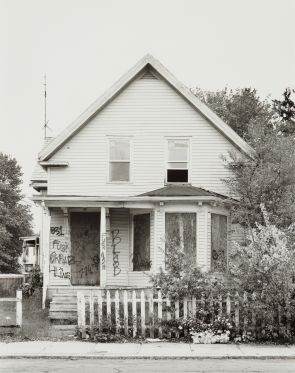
[166,139,189,183]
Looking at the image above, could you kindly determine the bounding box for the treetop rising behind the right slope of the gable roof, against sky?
[192,88,275,142]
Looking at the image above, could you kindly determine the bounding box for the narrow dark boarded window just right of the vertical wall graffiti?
[133,214,151,271]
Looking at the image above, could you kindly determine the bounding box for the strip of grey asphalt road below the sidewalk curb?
[0,359,295,373]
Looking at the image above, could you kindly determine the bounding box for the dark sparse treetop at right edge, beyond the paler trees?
[273,88,295,135]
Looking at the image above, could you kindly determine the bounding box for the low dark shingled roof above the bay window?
[138,184,228,199]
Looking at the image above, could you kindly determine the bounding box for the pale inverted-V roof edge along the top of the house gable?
[39,54,254,161]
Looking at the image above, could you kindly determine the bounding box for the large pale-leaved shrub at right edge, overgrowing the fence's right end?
[229,206,295,340]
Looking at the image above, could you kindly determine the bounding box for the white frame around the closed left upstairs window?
[106,136,133,184]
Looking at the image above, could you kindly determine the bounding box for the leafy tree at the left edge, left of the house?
[0,153,32,273]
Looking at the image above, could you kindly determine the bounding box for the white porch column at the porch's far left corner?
[40,202,50,308]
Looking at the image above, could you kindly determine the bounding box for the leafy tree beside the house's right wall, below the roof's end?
[225,130,295,228]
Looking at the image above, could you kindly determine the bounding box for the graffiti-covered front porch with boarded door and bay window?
[35,187,230,320]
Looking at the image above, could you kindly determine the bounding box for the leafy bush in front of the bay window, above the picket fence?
[152,240,225,299]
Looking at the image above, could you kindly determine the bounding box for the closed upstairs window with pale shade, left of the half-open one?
[109,138,130,181]
